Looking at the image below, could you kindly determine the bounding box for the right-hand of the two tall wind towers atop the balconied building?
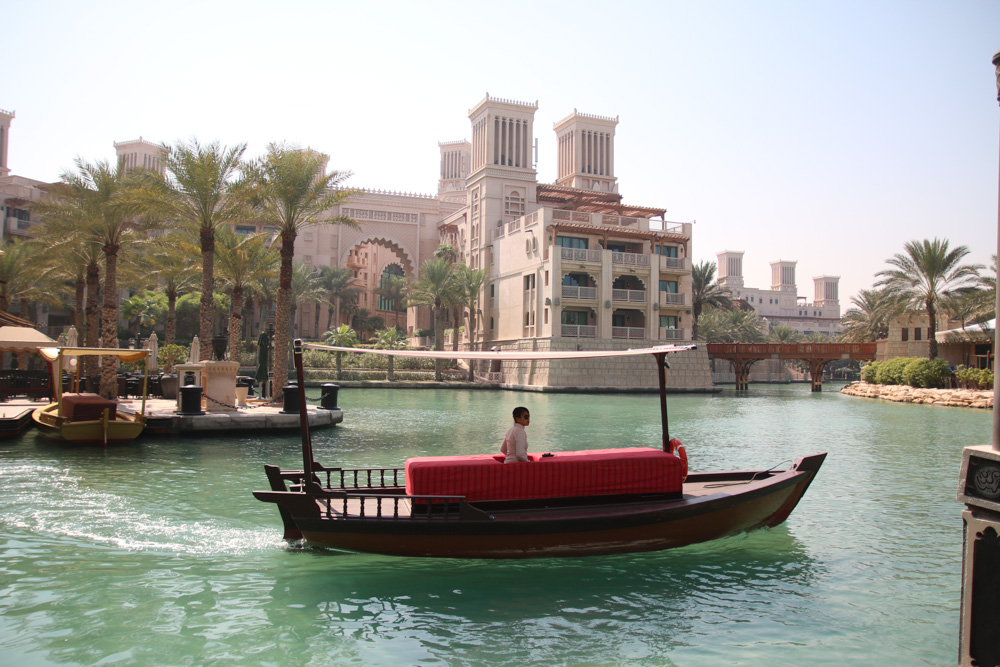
[553,109,618,193]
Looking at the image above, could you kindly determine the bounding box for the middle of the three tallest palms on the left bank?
[132,139,247,360]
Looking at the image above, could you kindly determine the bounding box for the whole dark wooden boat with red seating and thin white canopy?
[254,341,826,558]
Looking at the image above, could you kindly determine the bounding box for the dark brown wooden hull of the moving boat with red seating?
[254,454,826,558]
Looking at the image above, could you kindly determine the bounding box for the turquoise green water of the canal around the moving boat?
[0,385,992,666]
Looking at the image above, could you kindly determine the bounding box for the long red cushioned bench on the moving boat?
[406,447,684,502]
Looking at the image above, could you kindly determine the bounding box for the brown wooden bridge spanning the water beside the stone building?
[706,343,875,391]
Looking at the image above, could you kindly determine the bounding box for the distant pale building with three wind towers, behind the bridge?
[716,250,842,338]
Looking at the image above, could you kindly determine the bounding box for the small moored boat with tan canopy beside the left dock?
[31,347,149,445]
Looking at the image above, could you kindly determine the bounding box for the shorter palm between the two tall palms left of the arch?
[215,227,278,361]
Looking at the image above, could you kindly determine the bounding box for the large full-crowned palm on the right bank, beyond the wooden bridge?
[875,238,983,359]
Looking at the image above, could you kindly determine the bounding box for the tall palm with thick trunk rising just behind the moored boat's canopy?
[38,158,156,399]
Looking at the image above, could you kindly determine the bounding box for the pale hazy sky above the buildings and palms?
[0,0,1000,310]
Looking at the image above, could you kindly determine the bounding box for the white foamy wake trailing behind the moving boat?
[0,463,284,556]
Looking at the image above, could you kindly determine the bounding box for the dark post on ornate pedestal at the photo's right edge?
[958,45,1000,667]
